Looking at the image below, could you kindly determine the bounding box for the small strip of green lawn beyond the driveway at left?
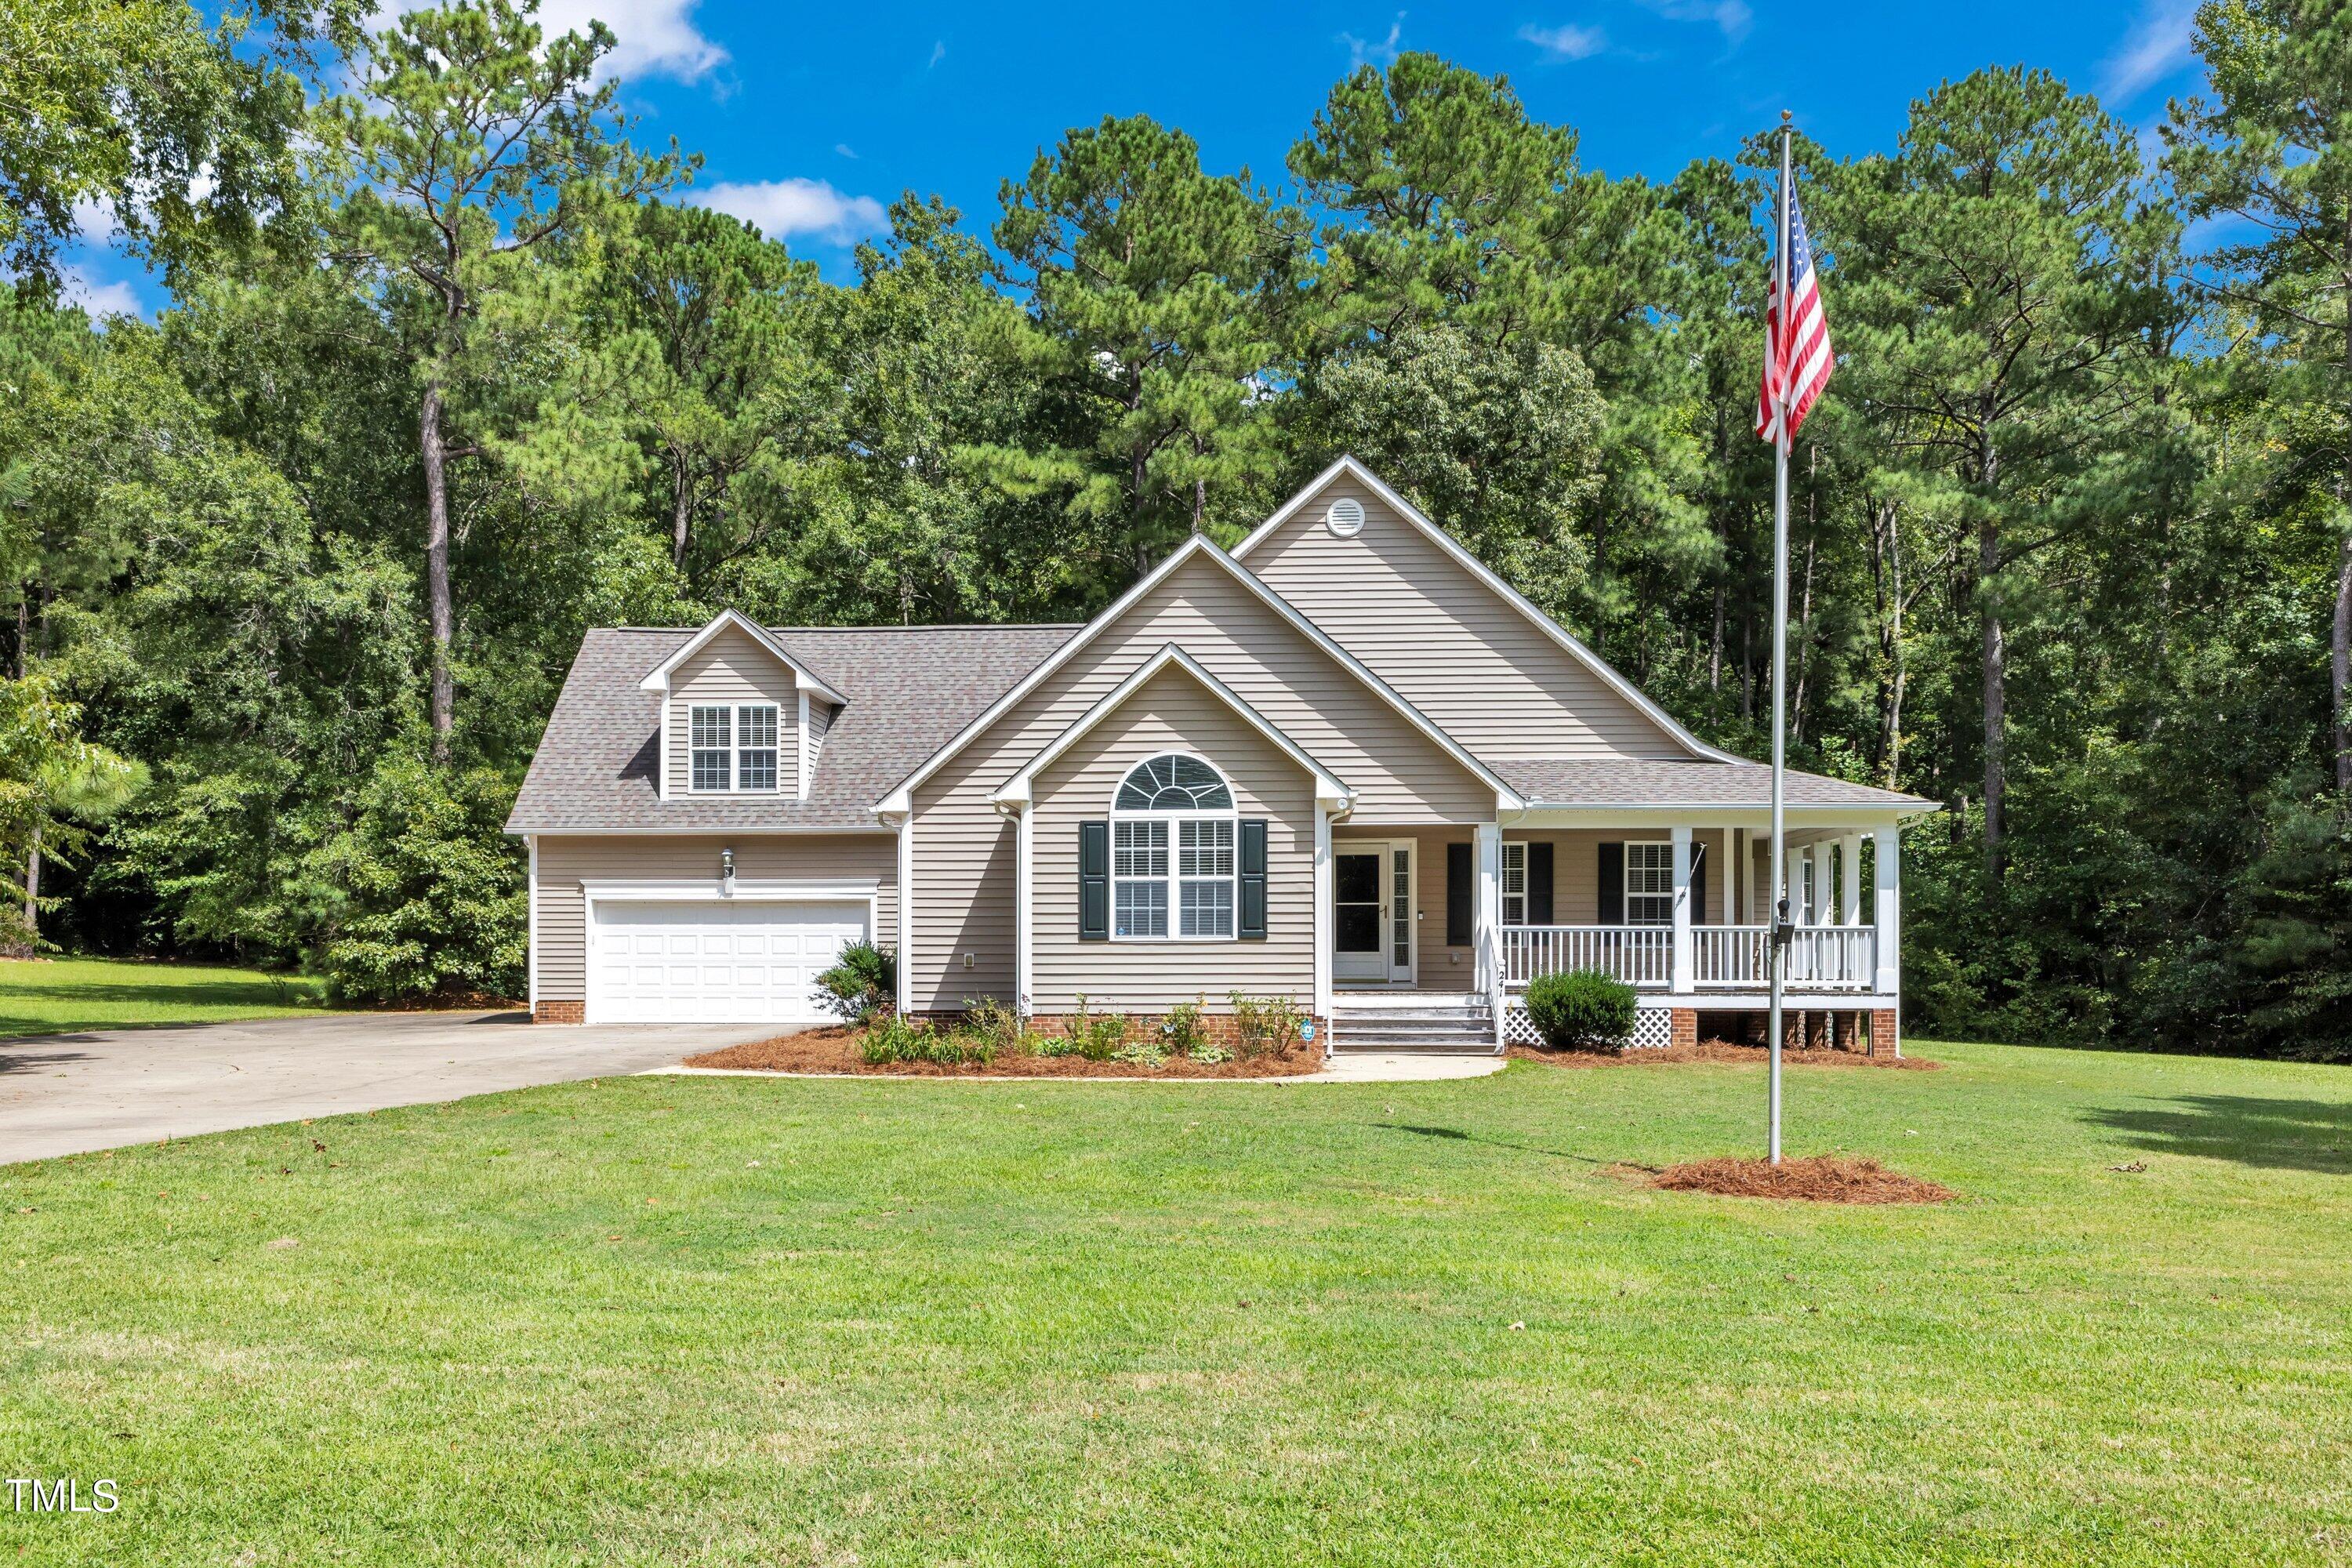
[0,959,322,1044]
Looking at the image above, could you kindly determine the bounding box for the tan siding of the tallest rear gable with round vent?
[1242,475,1691,760]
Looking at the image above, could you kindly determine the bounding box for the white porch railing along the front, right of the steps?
[1503,926,1879,992]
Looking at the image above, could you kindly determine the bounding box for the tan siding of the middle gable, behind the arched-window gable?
[908,557,1494,1011]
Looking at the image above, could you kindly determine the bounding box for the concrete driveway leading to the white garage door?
[0,1013,776,1163]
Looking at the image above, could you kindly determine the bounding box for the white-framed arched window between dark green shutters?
[1110,753,1237,938]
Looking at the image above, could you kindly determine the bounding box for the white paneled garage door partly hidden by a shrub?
[588,898,866,1022]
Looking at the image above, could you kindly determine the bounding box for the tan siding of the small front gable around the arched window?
[1030,668,1315,1013]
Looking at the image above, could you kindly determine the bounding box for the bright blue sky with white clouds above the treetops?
[75,0,2197,308]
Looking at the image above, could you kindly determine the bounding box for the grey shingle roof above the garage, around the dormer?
[506,626,1077,832]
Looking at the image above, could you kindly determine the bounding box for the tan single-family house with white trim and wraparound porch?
[508,459,1933,1048]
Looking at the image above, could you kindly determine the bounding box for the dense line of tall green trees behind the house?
[0,0,2352,1055]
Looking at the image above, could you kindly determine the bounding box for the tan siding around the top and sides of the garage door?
[532,832,898,1001]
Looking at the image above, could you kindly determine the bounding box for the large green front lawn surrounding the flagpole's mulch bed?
[0,1046,2352,1568]
